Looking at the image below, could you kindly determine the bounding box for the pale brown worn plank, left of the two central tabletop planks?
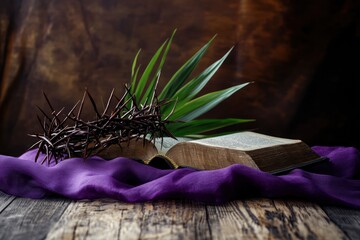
[46,200,210,239]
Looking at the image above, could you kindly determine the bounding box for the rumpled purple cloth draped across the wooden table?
[0,147,360,208]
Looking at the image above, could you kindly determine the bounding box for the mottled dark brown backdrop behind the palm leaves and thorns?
[0,0,360,155]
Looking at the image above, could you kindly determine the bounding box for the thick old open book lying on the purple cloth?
[101,131,325,174]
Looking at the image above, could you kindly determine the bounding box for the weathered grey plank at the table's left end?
[0,196,70,239]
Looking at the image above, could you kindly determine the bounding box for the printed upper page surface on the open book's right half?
[191,131,301,151]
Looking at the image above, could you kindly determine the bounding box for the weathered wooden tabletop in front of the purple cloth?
[0,192,360,240]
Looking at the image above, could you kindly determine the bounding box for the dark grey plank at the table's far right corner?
[323,207,360,240]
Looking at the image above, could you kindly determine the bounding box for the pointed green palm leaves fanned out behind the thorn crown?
[126,31,253,137]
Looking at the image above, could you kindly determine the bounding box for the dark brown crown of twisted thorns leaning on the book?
[29,86,175,164]
